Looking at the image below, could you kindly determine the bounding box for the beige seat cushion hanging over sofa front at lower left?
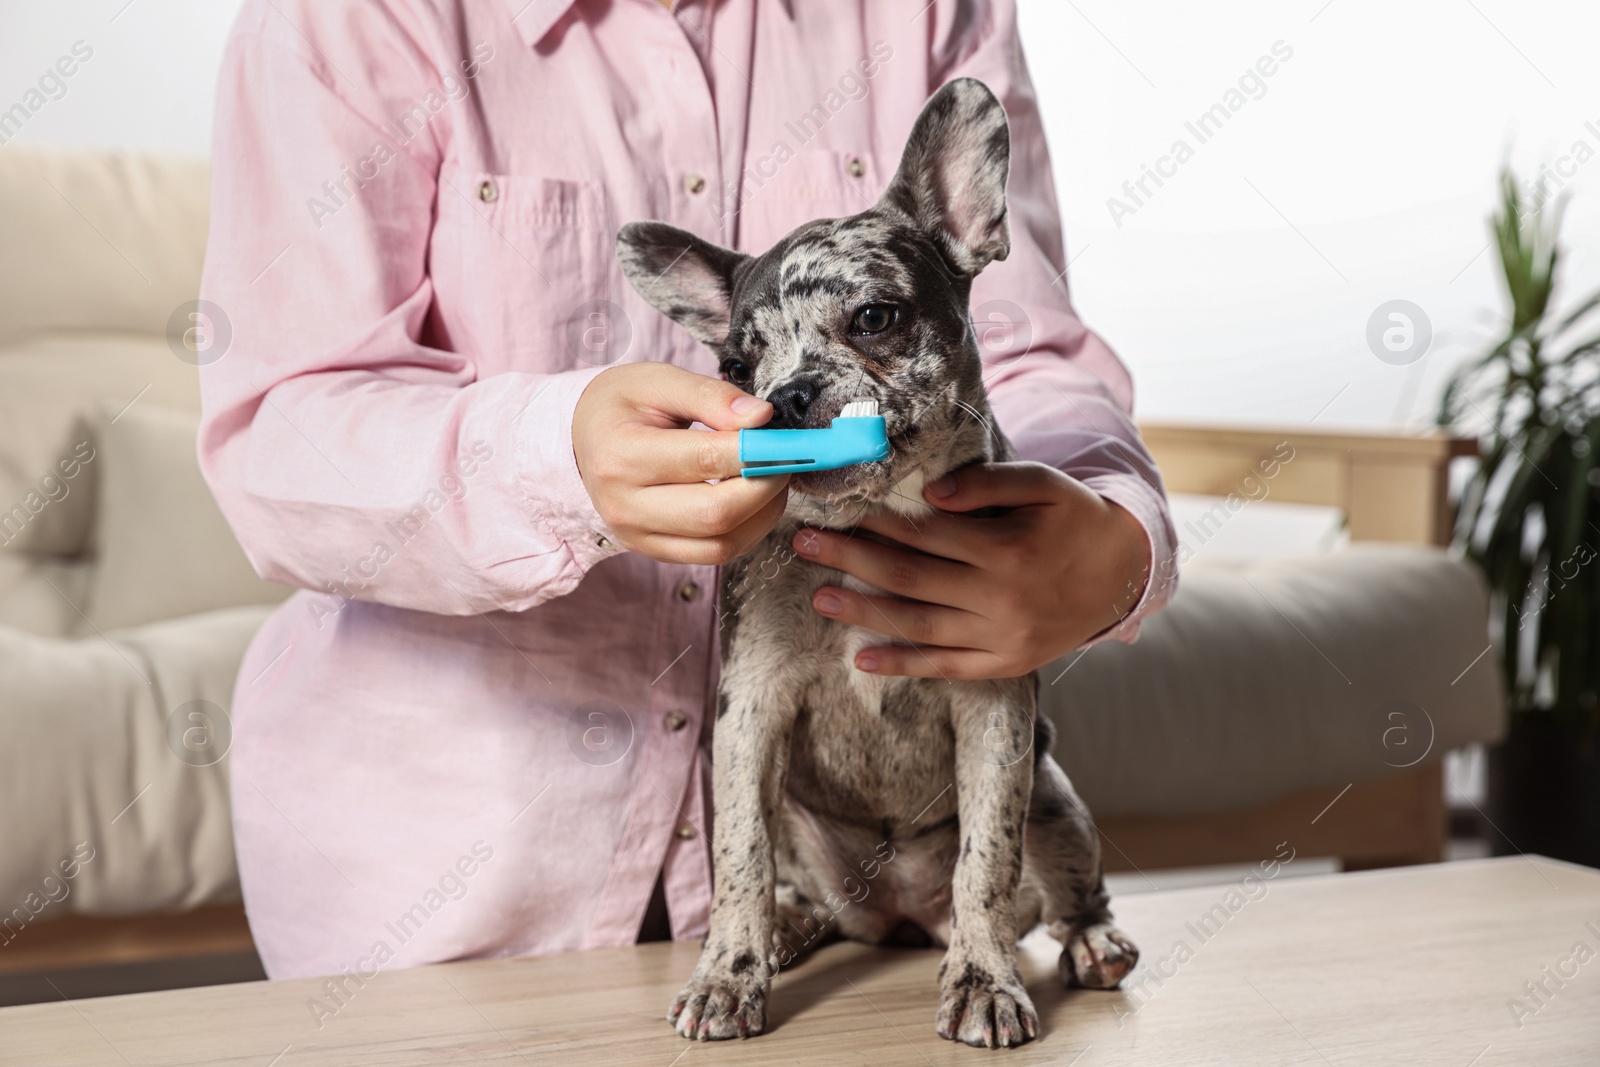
[0,606,272,921]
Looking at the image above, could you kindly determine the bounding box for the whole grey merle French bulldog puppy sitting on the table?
[618,80,1138,1046]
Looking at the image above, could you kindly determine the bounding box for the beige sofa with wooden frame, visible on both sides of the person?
[0,147,1502,979]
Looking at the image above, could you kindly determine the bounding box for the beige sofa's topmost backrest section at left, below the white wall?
[0,146,210,344]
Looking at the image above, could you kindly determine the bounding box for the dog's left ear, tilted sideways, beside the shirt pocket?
[616,222,749,347]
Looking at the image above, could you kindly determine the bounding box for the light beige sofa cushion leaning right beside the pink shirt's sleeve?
[74,400,290,637]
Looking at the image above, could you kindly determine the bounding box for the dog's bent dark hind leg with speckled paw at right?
[1024,753,1139,989]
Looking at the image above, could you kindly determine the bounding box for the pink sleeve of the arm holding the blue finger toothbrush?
[198,3,618,614]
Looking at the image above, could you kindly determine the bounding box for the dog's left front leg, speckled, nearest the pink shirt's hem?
[667,681,798,1040]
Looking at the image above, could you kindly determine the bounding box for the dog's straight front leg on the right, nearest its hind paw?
[936,678,1038,1048]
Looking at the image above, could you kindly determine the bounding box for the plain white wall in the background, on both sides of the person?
[0,0,1600,426]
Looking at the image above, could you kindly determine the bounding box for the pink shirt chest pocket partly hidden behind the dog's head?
[739,149,899,254]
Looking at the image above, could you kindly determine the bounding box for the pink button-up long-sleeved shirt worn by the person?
[200,0,1173,977]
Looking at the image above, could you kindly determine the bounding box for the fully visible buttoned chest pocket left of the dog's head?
[430,171,632,373]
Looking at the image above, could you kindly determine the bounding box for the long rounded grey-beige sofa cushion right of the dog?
[1040,544,1504,814]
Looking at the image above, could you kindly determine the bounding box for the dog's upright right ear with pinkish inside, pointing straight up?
[883,78,1011,277]
